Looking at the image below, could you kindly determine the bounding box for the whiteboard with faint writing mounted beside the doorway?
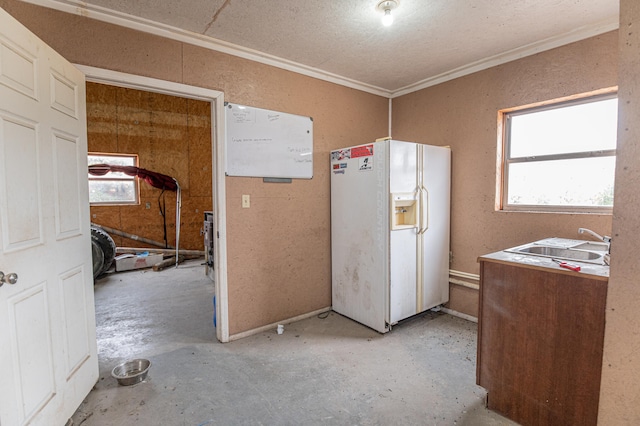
[225,103,313,179]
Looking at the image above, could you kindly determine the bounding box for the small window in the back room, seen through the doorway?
[89,153,139,204]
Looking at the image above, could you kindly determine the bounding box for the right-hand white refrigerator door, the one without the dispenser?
[419,145,451,310]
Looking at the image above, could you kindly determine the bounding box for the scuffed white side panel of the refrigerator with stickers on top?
[331,142,389,333]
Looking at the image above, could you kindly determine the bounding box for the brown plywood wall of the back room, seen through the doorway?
[87,83,213,250]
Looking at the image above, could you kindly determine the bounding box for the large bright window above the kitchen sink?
[499,93,618,213]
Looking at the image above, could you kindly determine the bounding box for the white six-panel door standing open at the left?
[0,9,98,426]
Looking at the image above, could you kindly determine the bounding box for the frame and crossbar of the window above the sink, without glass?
[495,86,618,214]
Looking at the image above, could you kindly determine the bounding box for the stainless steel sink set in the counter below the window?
[505,238,608,265]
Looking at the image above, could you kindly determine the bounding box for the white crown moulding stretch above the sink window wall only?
[391,17,619,98]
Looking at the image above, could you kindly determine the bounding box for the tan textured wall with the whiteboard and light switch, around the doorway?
[0,0,388,335]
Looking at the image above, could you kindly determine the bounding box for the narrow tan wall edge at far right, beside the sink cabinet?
[598,0,640,425]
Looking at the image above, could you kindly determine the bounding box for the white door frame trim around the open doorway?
[75,64,229,342]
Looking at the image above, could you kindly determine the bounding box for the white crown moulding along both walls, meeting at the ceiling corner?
[23,0,619,98]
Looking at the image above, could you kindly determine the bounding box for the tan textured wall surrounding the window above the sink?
[392,32,617,315]
